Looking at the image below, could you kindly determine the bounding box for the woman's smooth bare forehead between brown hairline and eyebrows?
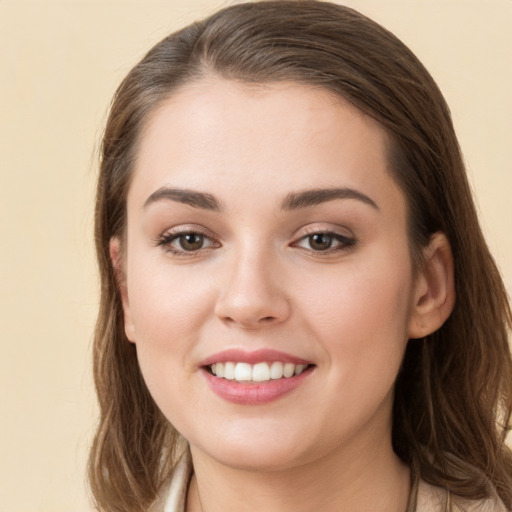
[129,76,400,214]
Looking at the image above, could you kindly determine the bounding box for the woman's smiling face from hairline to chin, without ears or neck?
[118,77,422,469]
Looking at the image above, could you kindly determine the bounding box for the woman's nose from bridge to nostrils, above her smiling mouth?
[215,247,290,329]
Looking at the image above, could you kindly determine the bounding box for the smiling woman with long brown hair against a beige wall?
[90,1,512,512]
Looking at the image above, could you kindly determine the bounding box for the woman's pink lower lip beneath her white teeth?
[202,367,313,405]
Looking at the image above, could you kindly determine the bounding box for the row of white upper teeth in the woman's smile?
[210,361,307,382]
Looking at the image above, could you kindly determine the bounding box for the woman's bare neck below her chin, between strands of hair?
[187,432,410,512]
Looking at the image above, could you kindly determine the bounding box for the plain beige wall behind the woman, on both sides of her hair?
[0,0,512,512]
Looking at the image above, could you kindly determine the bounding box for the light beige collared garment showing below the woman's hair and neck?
[149,453,507,512]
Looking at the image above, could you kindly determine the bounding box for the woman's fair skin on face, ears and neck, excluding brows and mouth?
[111,76,453,512]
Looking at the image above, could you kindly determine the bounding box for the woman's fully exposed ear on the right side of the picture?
[408,233,455,338]
